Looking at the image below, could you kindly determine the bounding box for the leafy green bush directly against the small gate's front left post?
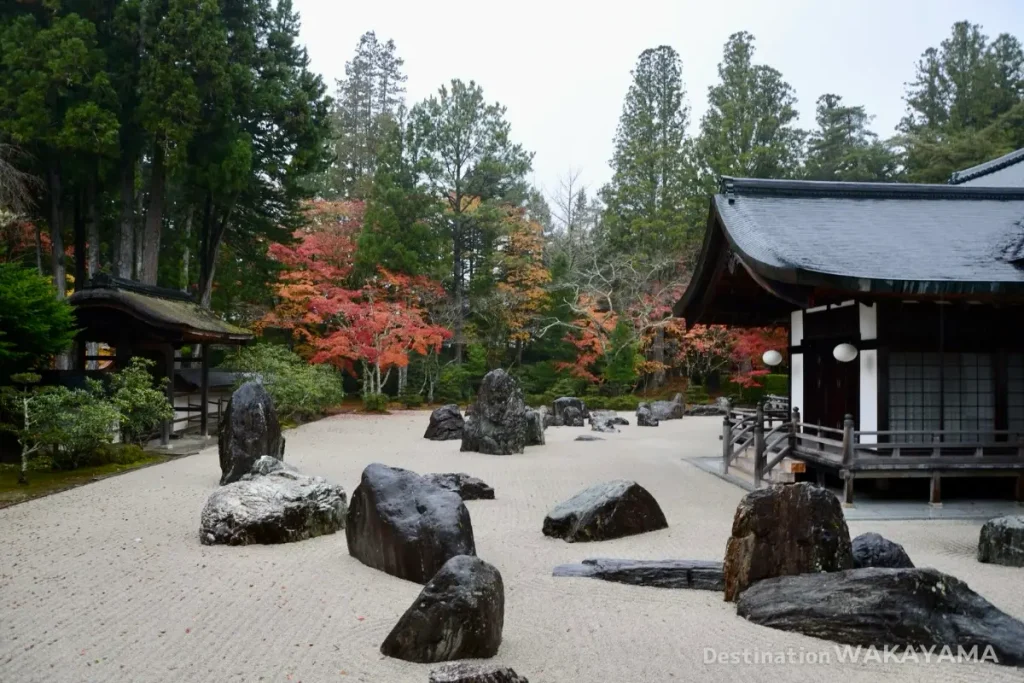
[110,357,174,443]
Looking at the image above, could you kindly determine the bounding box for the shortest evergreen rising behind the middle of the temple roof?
[804,94,899,181]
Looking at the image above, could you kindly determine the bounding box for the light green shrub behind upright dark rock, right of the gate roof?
[224,343,345,422]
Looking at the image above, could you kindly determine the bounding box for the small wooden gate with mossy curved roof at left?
[69,275,253,445]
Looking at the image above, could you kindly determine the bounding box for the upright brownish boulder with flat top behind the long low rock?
[725,483,853,601]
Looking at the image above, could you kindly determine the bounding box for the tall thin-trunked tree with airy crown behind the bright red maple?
[411,79,532,362]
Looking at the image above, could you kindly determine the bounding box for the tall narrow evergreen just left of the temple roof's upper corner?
[603,45,692,257]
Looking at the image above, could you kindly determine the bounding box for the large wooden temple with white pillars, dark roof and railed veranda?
[675,165,1024,503]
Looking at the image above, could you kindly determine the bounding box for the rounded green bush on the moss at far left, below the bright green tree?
[34,380,121,470]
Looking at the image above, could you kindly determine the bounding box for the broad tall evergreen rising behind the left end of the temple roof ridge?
[697,33,804,181]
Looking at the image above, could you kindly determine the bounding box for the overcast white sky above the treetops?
[294,0,1024,197]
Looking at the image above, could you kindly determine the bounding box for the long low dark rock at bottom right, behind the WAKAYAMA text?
[736,567,1024,666]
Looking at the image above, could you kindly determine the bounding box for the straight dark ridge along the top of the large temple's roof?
[721,176,1024,200]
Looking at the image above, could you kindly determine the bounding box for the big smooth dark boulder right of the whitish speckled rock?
[345,463,476,584]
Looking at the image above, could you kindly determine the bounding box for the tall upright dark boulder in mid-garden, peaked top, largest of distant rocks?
[462,370,527,456]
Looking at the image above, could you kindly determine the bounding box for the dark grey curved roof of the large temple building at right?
[714,178,1024,294]
